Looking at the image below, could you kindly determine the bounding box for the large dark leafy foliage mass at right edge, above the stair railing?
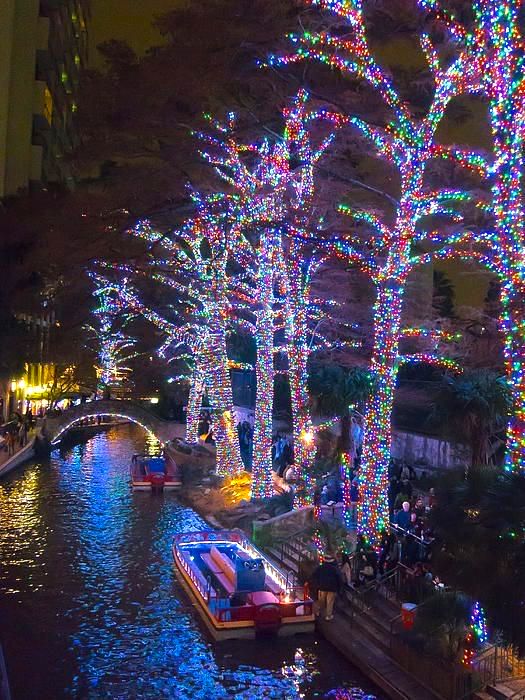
[431,469,525,652]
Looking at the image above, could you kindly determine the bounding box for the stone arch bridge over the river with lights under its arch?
[40,399,186,445]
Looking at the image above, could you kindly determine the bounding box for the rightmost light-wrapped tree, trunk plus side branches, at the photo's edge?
[419,0,525,472]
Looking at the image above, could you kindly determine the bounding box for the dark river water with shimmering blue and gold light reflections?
[0,427,379,700]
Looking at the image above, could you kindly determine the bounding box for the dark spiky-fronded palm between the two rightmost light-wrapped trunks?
[430,369,511,466]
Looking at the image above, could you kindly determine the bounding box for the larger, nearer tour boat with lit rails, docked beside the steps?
[173,530,315,640]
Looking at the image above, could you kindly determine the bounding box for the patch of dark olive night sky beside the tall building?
[89,0,178,65]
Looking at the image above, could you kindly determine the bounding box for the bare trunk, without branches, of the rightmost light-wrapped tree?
[476,0,525,473]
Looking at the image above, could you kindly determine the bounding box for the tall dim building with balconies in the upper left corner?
[0,0,89,198]
